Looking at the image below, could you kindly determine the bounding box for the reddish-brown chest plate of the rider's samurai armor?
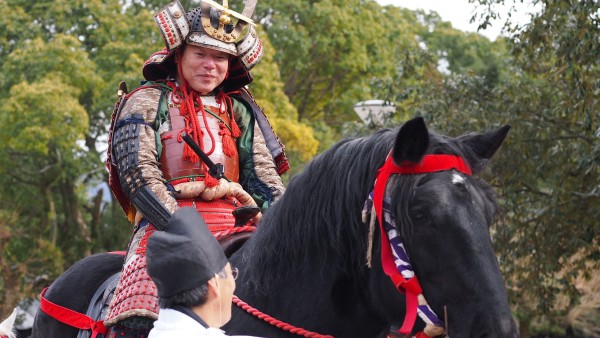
[160,107,240,182]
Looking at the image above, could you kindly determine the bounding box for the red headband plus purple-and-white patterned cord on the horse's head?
[366,152,472,335]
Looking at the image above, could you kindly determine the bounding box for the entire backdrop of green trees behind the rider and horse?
[0,0,600,337]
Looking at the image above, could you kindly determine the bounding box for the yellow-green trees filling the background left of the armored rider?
[0,0,160,314]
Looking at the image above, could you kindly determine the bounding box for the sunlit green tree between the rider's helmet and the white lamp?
[258,0,416,131]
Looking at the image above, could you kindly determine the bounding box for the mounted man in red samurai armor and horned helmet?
[104,0,289,338]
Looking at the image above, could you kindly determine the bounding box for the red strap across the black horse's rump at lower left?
[40,288,108,338]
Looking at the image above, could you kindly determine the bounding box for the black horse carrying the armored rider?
[33,118,518,338]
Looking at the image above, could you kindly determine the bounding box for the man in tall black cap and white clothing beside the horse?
[147,208,260,338]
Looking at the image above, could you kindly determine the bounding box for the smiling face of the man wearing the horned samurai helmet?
[181,45,229,95]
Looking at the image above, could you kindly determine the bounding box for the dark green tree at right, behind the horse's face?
[386,1,600,336]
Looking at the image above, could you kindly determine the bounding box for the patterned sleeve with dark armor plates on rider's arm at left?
[113,88,177,229]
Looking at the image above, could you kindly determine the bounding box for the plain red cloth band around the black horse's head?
[373,153,472,334]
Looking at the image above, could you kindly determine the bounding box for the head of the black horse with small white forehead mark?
[371,118,518,337]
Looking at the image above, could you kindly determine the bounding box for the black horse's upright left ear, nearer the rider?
[392,117,429,164]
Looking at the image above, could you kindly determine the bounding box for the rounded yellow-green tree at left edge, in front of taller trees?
[0,75,90,313]
